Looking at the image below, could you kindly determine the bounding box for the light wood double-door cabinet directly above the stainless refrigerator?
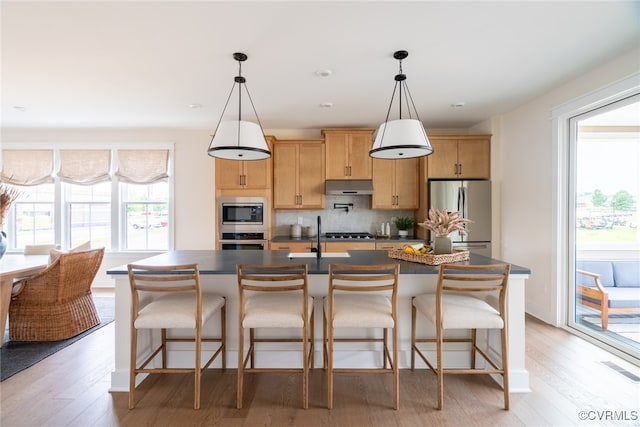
[427,135,491,179]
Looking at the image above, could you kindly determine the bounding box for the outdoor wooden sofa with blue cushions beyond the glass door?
[576,260,640,330]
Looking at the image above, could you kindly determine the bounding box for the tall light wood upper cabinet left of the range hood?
[273,140,325,209]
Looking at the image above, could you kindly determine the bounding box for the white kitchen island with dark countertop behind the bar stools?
[107,250,531,392]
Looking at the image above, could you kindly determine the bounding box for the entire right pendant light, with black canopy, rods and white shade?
[369,50,433,159]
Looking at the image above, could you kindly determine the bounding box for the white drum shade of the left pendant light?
[208,120,271,160]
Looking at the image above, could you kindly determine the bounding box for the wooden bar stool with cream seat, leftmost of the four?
[127,264,226,409]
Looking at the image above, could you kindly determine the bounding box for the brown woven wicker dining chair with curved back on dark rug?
[9,248,104,341]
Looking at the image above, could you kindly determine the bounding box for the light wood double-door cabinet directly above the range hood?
[322,129,374,179]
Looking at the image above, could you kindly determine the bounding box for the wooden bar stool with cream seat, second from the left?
[236,264,314,409]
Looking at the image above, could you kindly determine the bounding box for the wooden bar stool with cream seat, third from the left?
[323,264,400,409]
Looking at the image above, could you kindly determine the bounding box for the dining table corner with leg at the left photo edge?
[0,254,49,347]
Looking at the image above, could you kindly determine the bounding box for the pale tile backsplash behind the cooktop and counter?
[274,196,413,236]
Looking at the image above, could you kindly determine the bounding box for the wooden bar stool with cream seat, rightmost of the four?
[411,264,511,409]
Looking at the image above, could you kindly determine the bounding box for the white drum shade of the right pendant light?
[369,119,433,159]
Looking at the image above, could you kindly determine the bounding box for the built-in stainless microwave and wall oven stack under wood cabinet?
[218,197,269,250]
